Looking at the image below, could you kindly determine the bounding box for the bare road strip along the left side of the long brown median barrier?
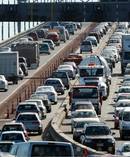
[0,22,90,102]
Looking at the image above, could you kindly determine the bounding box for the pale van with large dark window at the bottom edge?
[10,141,74,157]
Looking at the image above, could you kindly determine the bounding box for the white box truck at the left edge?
[0,51,19,84]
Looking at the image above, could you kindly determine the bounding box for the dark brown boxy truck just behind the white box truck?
[11,41,40,69]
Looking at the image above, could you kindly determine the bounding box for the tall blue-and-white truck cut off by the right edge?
[121,34,130,74]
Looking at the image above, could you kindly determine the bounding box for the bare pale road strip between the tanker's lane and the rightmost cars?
[101,62,125,151]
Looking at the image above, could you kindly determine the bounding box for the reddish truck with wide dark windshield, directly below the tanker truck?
[69,85,102,115]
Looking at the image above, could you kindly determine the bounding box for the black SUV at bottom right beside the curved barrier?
[80,122,115,154]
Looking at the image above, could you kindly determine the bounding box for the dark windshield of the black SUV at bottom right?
[85,126,111,136]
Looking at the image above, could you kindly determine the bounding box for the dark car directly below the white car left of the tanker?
[51,71,70,89]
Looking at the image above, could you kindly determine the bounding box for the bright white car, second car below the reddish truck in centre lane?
[71,109,100,132]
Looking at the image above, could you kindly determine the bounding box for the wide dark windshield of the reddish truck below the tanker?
[72,87,98,99]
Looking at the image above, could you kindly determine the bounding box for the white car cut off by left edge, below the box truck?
[0,75,8,92]
